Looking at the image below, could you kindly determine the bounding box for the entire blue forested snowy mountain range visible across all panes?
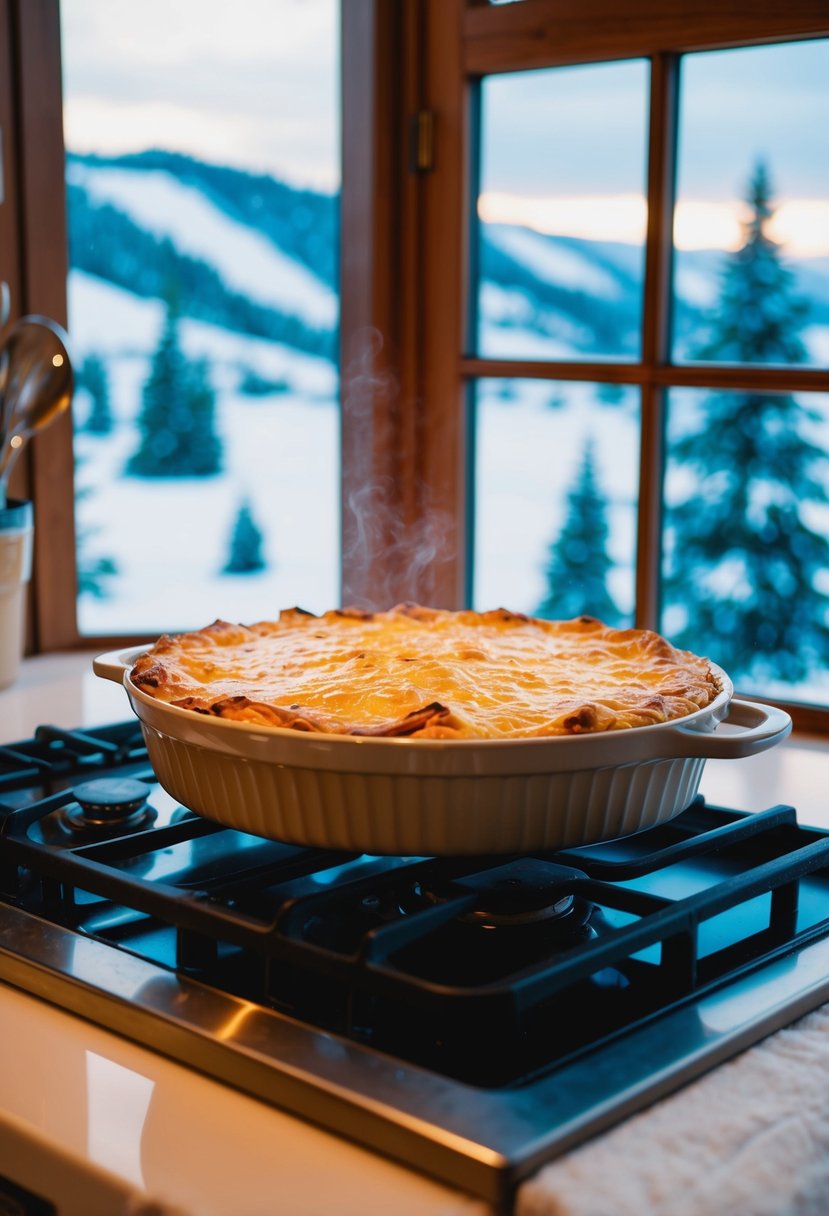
[67,152,829,359]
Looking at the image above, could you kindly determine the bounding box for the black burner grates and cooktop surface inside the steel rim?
[0,724,829,1087]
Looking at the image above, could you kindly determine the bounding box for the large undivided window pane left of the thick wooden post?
[61,0,339,635]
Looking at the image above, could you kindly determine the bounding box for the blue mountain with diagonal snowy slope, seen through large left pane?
[67,152,337,360]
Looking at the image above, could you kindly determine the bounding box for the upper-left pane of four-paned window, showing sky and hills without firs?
[473,61,648,359]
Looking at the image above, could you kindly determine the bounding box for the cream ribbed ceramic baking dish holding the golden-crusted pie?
[94,647,791,856]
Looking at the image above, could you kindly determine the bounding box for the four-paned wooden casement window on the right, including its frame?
[405,0,829,724]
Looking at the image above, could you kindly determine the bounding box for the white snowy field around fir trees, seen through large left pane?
[69,275,339,636]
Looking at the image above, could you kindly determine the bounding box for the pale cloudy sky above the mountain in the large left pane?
[63,0,339,187]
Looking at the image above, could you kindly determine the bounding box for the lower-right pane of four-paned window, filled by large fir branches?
[662,379,829,705]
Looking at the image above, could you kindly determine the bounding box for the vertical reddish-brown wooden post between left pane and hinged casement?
[340,0,405,607]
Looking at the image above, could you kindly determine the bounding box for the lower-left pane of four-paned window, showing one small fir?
[473,379,639,625]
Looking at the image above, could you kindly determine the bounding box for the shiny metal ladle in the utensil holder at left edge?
[0,316,73,502]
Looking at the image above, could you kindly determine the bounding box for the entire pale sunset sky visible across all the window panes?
[61,0,829,257]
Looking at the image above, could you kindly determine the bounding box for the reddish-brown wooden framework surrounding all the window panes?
[0,0,829,730]
